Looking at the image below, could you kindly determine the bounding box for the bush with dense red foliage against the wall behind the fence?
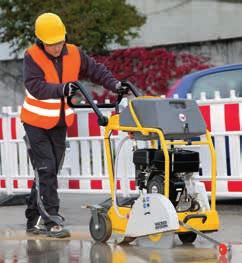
[94,48,212,101]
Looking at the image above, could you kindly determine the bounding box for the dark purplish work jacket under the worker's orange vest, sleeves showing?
[23,42,118,126]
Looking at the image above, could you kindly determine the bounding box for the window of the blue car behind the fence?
[191,70,242,99]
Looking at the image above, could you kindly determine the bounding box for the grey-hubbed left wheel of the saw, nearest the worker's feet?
[89,213,112,242]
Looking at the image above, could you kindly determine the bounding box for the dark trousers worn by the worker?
[24,123,66,225]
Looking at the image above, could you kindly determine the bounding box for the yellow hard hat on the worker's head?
[35,13,66,44]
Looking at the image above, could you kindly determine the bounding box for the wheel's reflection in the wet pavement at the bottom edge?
[89,242,112,263]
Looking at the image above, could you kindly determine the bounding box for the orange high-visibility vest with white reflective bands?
[20,44,81,129]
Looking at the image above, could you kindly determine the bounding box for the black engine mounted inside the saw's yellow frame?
[133,148,200,212]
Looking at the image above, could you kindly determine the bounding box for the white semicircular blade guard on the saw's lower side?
[125,193,179,237]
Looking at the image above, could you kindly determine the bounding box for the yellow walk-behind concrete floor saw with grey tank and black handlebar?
[68,82,227,256]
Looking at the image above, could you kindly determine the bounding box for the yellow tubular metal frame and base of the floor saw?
[104,96,219,237]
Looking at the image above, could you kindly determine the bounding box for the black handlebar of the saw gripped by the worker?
[67,81,140,126]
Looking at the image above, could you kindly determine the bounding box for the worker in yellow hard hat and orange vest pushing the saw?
[20,13,122,238]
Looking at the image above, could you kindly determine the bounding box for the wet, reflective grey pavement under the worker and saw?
[0,195,242,263]
